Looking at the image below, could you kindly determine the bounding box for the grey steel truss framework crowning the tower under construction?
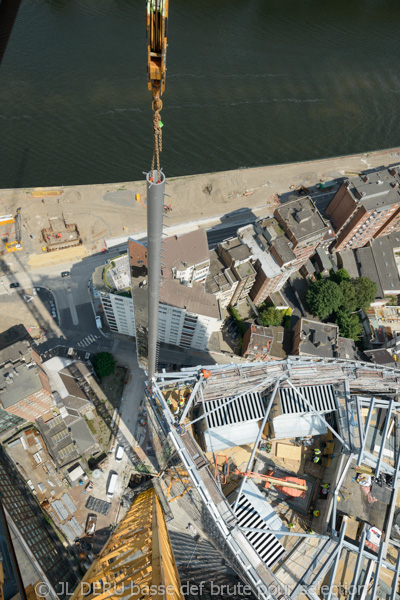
[152,357,400,600]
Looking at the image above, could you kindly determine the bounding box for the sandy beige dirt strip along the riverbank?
[0,148,400,266]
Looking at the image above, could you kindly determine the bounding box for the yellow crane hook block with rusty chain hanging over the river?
[147,0,168,181]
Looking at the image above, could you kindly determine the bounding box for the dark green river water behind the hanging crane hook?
[0,0,400,188]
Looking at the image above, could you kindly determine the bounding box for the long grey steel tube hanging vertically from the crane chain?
[146,170,165,387]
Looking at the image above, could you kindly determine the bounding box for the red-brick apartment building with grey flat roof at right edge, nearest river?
[326,167,400,252]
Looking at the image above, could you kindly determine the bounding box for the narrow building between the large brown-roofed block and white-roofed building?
[217,237,257,306]
